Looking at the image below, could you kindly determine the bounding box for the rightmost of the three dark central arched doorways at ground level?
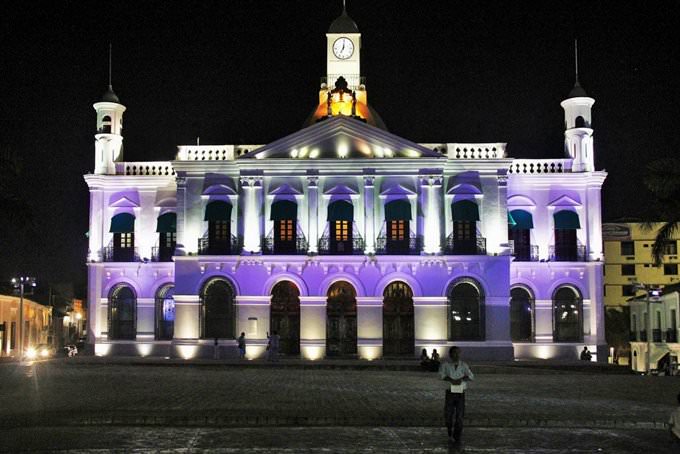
[383,282,415,356]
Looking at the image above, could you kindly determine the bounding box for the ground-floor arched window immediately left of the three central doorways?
[201,278,236,339]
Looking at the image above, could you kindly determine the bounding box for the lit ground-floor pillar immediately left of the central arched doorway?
[300,296,326,360]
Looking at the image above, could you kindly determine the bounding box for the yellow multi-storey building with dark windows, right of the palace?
[602,222,680,309]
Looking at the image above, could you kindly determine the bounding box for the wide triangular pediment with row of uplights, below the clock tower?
[239,116,446,159]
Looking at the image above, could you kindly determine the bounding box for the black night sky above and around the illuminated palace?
[0,0,680,294]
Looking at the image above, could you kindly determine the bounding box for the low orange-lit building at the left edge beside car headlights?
[0,295,52,356]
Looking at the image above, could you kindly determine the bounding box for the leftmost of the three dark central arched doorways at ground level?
[269,281,300,355]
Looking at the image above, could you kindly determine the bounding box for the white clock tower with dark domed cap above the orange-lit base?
[326,2,361,90]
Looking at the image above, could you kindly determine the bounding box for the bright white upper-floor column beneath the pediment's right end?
[418,175,443,254]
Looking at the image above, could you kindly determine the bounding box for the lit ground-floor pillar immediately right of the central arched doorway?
[357,296,383,360]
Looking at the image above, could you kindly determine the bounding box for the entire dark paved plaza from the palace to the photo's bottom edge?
[0,359,680,453]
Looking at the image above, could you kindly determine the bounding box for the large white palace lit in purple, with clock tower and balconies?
[85,6,606,359]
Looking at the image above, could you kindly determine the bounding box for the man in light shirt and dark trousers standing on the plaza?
[439,347,475,444]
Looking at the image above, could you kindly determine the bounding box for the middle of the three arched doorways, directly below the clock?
[326,281,357,356]
